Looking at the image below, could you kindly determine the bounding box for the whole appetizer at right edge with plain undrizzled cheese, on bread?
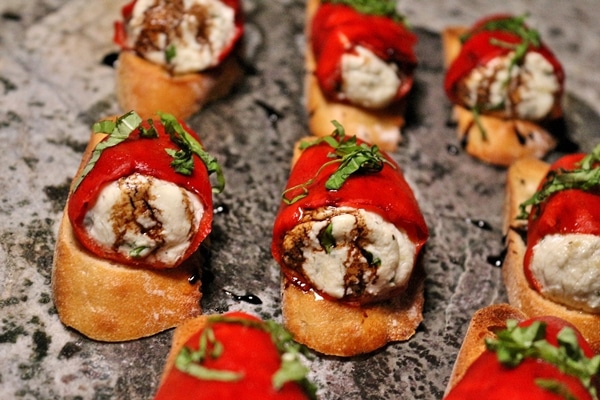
[503,146,600,351]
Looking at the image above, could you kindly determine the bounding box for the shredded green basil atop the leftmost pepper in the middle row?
[73,111,225,193]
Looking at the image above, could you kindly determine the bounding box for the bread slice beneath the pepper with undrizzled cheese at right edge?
[502,159,600,353]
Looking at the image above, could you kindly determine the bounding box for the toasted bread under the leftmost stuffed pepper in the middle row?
[51,130,202,342]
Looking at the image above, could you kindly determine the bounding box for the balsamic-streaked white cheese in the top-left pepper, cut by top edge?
[128,0,236,73]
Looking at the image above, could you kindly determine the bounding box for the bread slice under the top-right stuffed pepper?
[442,26,562,167]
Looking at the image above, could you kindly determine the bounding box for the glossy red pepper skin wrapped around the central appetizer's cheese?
[271,134,429,296]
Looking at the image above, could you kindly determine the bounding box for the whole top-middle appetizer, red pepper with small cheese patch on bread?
[305,0,417,151]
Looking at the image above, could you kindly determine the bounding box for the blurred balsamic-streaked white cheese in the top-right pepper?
[461,52,560,120]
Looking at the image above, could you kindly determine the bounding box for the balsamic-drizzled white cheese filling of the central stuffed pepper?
[283,207,416,302]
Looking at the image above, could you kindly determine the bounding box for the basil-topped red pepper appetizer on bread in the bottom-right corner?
[444,304,600,400]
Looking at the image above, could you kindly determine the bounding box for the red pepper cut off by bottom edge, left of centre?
[155,312,311,400]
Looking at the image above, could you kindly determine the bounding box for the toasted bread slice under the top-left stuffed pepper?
[116,50,243,119]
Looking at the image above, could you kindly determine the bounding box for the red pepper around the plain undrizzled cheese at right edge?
[524,154,600,290]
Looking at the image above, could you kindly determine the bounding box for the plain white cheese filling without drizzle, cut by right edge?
[529,234,600,313]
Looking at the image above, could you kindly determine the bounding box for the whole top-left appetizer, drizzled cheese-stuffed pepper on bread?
[114,0,244,119]
